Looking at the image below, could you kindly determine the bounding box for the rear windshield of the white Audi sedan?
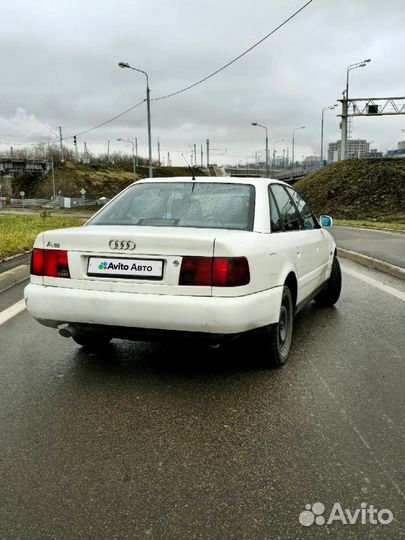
[89,181,255,231]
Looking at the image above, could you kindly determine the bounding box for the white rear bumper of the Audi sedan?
[24,283,283,334]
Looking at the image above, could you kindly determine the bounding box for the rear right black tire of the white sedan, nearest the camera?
[265,285,294,367]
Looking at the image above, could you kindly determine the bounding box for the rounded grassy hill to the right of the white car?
[294,158,405,223]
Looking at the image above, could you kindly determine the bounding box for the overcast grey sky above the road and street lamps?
[0,0,405,164]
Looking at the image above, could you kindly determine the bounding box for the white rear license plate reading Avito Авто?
[87,257,163,280]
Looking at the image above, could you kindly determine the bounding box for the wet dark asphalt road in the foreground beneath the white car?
[0,261,405,540]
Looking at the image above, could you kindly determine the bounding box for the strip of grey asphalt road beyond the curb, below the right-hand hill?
[331,225,405,268]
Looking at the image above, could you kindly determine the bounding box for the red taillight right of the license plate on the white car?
[179,257,250,287]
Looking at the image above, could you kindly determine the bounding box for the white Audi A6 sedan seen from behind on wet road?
[25,177,341,366]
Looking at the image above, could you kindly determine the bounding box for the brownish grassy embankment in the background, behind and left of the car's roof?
[13,161,204,199]
